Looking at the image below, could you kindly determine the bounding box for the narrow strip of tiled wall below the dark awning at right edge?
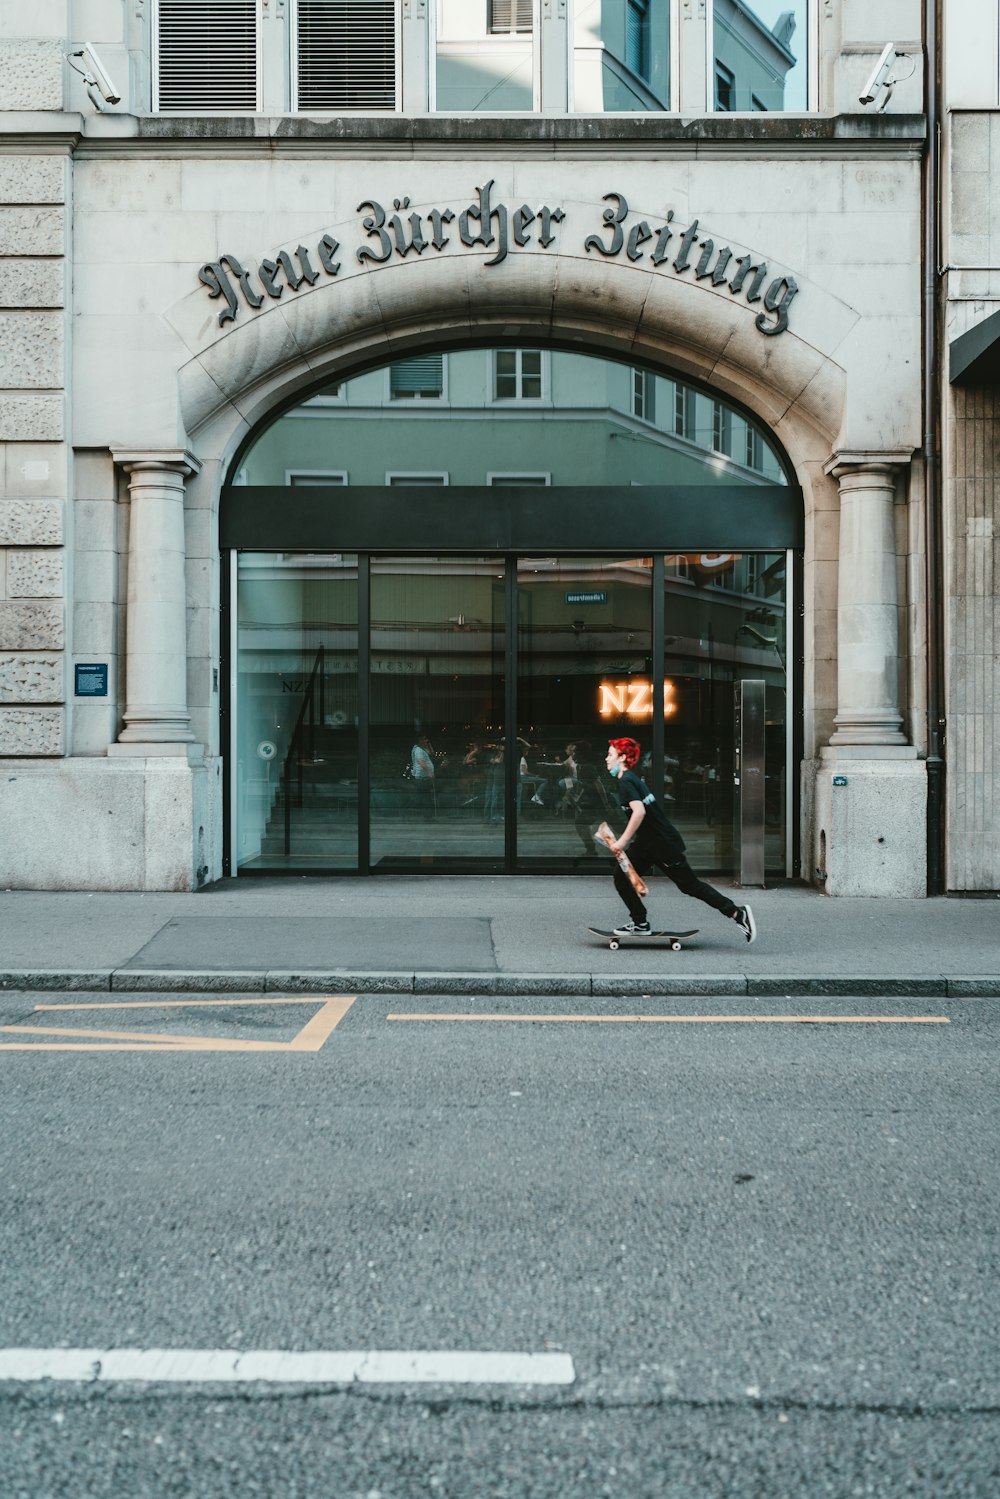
[945,387,1000,890]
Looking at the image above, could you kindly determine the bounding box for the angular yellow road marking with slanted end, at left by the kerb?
[0,995,355,1052]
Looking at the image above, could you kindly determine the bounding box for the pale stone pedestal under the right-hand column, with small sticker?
[810,745,927,898]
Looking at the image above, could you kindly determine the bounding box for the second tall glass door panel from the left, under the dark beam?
[370,556,505,868]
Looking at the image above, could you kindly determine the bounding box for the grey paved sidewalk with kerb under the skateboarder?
[0,875,1000,997]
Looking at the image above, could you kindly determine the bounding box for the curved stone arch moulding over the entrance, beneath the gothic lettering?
[166,227,858,513]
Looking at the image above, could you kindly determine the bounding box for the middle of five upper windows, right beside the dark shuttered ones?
[436,0,535,114]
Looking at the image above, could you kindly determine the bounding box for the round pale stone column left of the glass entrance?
[109,448,201,758]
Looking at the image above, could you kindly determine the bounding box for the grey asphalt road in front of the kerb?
[0,994,1000,1499]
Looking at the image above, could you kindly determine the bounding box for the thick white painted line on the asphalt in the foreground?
[0,1348,576,1385]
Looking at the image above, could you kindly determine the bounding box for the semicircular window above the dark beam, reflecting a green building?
[238,349,787,502]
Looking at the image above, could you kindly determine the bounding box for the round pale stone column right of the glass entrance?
[826,453,909,745]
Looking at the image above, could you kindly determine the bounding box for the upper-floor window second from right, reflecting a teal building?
[573,0,670,114]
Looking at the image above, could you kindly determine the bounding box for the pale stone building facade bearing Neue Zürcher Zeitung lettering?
[0,0,977,896]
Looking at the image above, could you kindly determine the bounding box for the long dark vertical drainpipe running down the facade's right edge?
[922,0,945,895]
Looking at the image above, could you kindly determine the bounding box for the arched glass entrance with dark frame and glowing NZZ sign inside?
[220,342,804,875]
